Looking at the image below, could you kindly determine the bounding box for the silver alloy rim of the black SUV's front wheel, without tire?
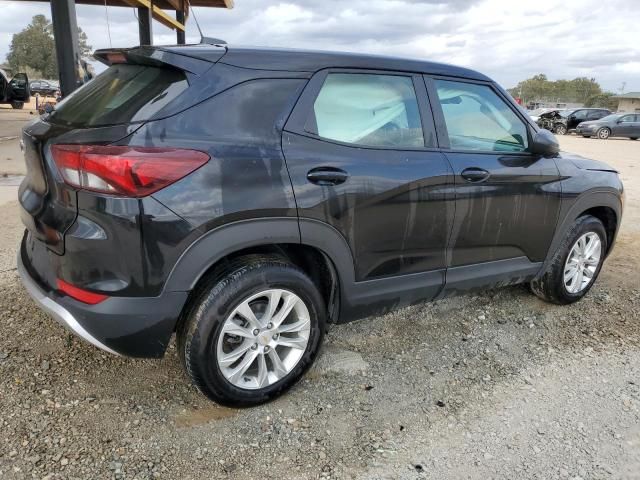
[564,232,602,294]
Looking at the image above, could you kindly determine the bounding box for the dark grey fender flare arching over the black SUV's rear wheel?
[164,217,355,292]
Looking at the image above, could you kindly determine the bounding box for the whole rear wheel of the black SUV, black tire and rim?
[178,256,326,407]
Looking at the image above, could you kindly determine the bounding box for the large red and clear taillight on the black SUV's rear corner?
[51,145,209,197]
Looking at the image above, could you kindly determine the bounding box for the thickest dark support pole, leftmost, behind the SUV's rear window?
[51,0,82,97]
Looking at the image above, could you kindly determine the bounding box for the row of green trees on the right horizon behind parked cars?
[508,73,617,110]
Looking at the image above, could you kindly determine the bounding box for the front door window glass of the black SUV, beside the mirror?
[435,80,528,152]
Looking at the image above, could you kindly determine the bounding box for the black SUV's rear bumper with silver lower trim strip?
[18,238,188,358]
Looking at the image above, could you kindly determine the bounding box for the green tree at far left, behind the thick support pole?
[7,15,92,78]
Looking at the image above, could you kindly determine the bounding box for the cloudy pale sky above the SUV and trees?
[0,0,640,92]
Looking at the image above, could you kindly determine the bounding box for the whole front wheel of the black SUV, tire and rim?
[531,215,607,305]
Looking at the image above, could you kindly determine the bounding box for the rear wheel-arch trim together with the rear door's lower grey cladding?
[164,217,445,322]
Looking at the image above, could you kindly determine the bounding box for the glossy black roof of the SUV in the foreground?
[162,44,491,81]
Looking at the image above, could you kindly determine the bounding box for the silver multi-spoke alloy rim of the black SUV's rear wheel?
[216,289,311,390]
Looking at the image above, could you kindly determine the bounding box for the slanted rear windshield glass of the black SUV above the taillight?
[49,64,189,127]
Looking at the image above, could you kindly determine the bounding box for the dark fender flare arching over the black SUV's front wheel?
[540,189,622,273]
